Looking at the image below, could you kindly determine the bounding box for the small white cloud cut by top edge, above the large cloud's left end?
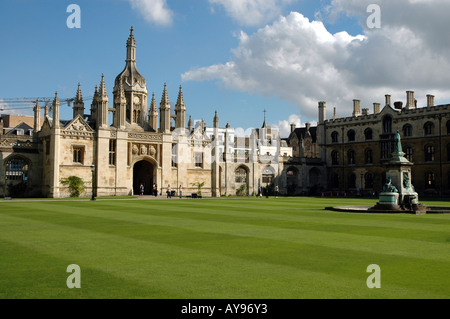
[209,0,294,26]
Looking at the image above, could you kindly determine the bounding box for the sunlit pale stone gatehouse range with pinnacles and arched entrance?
[0,28,292,198]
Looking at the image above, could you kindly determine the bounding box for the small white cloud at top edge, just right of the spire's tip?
[128,0,173,26]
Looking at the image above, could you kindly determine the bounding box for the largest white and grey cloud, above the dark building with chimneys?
[182,0,450,120]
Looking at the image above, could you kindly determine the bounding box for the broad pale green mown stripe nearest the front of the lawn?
[0,212,443,298]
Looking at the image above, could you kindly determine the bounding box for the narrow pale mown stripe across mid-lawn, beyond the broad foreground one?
[4,205,450,262]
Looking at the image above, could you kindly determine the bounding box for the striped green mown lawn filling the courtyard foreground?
[0,198,450,299]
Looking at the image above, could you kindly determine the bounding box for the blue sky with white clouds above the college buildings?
[0,0,450,135]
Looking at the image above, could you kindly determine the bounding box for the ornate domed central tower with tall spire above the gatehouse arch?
[113,27,147,127]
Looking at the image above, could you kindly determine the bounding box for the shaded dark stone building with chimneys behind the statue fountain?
[317,91,450,196]
